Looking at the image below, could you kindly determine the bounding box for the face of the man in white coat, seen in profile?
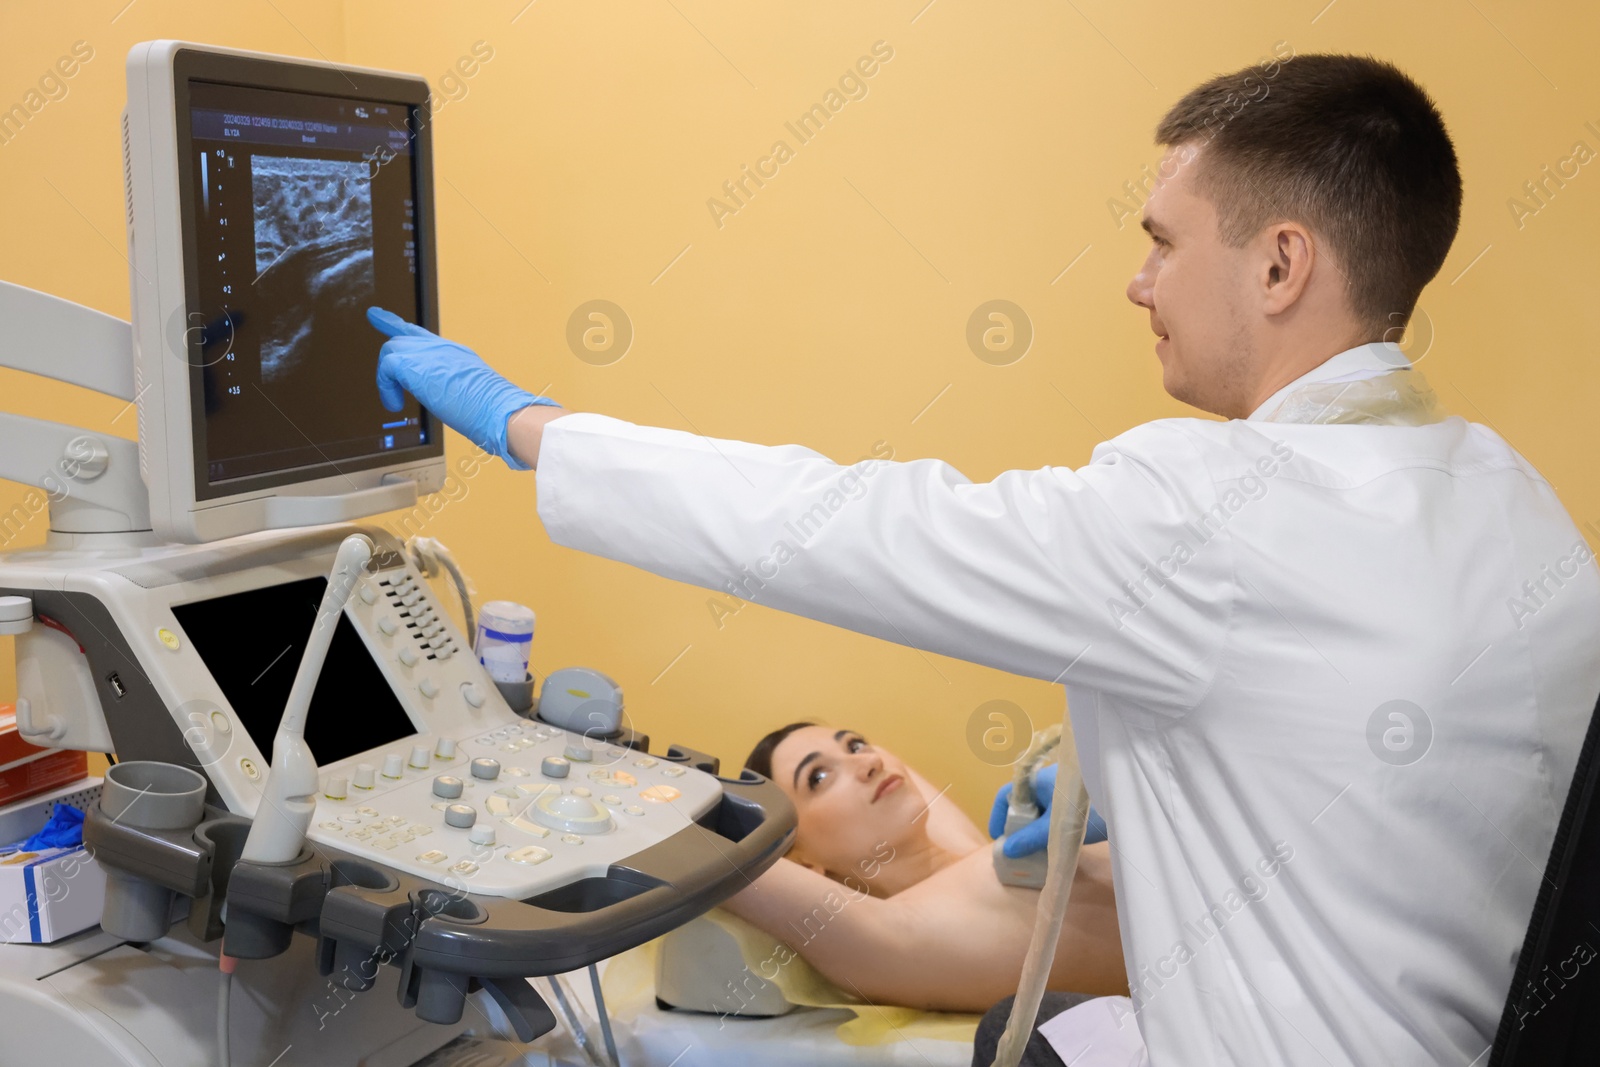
[1128,146,1256,418]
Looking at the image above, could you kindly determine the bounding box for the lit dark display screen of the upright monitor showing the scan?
[182,83,438,499]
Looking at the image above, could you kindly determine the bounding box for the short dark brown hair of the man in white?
[1155,53,1461,341]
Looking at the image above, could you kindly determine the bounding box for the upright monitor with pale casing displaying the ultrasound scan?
[123,42,445,542]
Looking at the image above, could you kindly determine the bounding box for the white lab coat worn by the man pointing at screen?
[538,346,1600,1067]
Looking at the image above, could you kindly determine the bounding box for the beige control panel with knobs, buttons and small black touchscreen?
[0,526,723,899]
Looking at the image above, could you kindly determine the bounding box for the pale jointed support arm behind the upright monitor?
[0,282,154,547]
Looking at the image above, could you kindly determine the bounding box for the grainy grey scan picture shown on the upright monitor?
[250,155,373,382]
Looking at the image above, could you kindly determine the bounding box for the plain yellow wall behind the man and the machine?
[0,0,1600,814]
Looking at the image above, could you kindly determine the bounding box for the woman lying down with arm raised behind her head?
[723,723,1128,1011]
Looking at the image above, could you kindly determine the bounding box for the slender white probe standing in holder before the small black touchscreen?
[242,534,373,864]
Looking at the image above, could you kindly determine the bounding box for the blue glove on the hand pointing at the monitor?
[366,307,560,470]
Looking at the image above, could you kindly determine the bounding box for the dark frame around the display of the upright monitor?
[173,48,445,506]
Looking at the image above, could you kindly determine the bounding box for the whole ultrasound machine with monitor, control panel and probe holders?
[0,42,794,1067]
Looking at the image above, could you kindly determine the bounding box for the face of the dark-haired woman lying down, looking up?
[773,726,928,878]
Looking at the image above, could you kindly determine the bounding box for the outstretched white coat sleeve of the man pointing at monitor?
[538,413,1234,712]
